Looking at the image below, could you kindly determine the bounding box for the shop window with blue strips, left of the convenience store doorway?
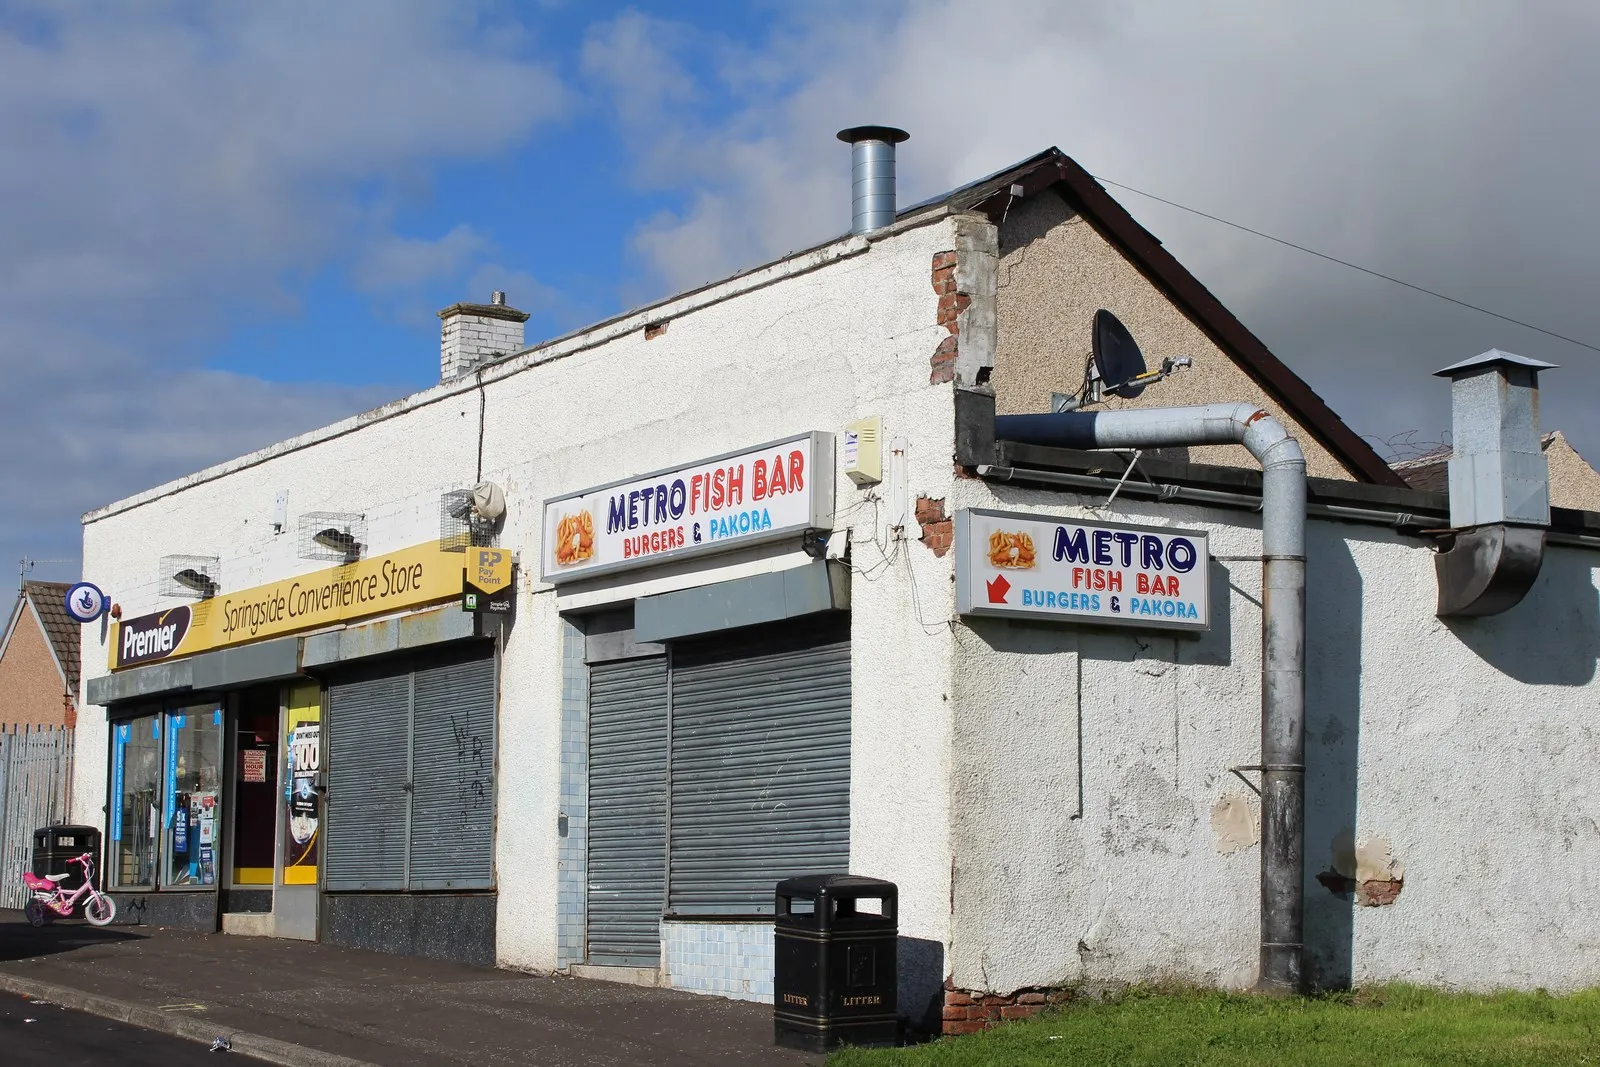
[107,704,222,889]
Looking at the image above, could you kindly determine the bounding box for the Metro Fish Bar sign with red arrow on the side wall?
[955,509,1210,630]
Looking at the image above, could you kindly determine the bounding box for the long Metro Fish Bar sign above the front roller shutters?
[539,432,834,584]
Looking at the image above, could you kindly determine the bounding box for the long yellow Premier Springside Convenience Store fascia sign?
[109,542,464,670]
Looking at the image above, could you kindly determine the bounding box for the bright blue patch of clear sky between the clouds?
[206,3,781,389]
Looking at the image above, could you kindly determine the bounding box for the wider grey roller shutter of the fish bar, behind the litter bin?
[669,616,850,913]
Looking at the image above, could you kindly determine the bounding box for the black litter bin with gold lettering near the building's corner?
[773,875,899,1053]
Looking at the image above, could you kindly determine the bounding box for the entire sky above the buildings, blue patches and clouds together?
[0,0,1600,577]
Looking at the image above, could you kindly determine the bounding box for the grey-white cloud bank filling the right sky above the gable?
[585,0,1600,454]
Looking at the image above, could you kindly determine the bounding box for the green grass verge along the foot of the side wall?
[827,985,1600,1067]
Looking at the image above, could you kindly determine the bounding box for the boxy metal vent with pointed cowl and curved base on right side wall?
[1434,349,1555,616]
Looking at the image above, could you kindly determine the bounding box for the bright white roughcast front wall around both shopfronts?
[75,214,955,969]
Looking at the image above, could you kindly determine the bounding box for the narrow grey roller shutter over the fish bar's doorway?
[587,656,667,966]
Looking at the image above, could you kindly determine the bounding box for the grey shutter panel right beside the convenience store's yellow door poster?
[323,664,411,891]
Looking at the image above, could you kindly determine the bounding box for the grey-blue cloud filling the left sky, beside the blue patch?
[0,0,568,572]
